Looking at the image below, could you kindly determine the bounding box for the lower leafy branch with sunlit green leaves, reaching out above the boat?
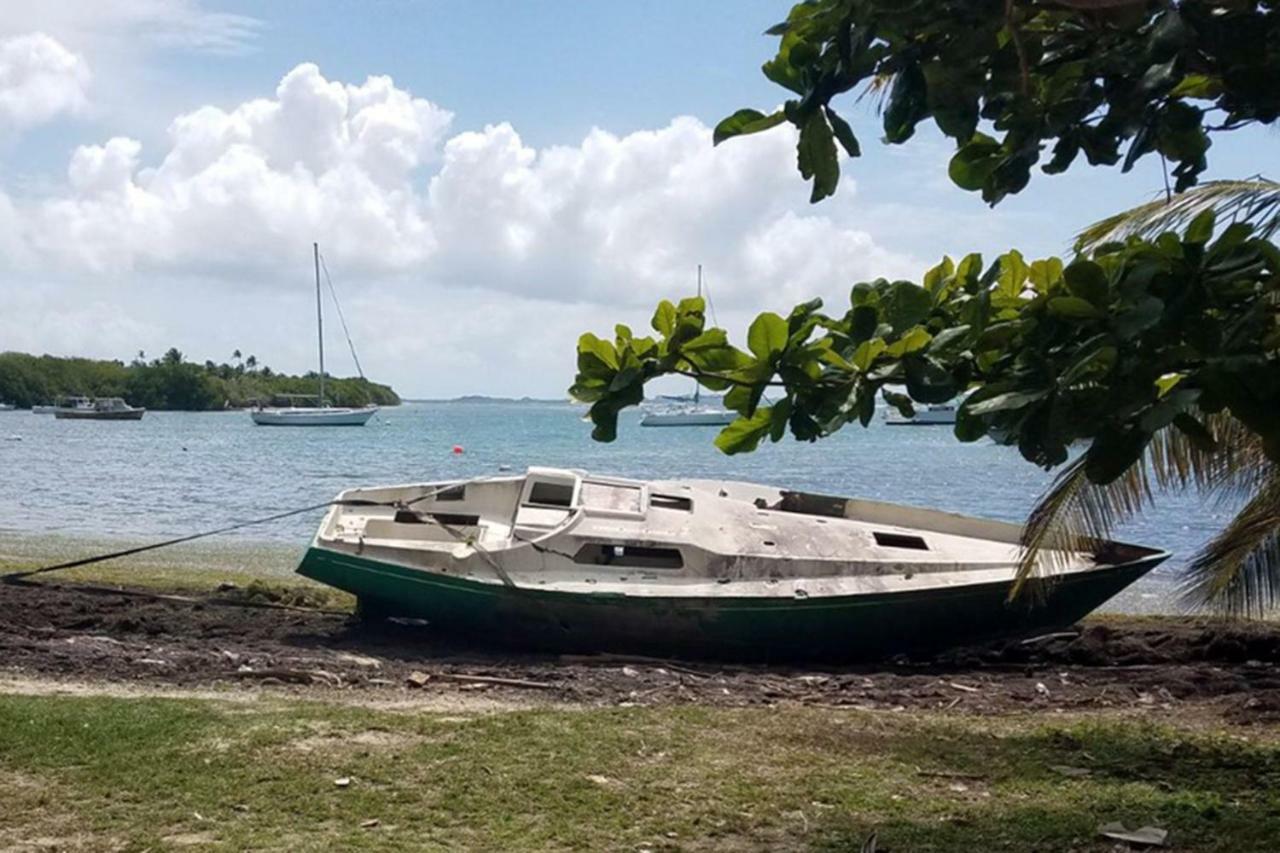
[571,211,1280,483]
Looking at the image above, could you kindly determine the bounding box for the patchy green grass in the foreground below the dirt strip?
[0,695,1280,852]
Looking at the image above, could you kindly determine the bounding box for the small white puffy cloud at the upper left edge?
[0,32,90,129]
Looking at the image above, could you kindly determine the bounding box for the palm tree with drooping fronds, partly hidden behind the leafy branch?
[1016,183,1280,616]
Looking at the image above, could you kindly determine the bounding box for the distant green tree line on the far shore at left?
[0,348,401,411]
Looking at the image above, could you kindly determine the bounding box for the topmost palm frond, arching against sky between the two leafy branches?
[1075,175,1280,252]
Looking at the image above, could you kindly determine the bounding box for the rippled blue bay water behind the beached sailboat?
[0,402,1230,611]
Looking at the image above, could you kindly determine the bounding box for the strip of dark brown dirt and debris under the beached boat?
[0,573,1280,725]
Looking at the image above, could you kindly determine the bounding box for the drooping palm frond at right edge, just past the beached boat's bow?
[1180,466,1280,616]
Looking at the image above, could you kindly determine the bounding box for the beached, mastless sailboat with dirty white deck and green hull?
[298,467,1169,660]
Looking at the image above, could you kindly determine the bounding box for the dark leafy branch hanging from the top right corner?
[714,0,1280,205]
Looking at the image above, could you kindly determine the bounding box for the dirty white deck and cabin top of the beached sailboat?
[315,467,1152,598]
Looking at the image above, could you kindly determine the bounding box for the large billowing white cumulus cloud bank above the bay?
[20,64,915,304]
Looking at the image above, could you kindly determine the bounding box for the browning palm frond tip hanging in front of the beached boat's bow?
[1009,453,1153,598]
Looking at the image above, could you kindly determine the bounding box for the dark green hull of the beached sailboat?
[298,547,1167,660]
